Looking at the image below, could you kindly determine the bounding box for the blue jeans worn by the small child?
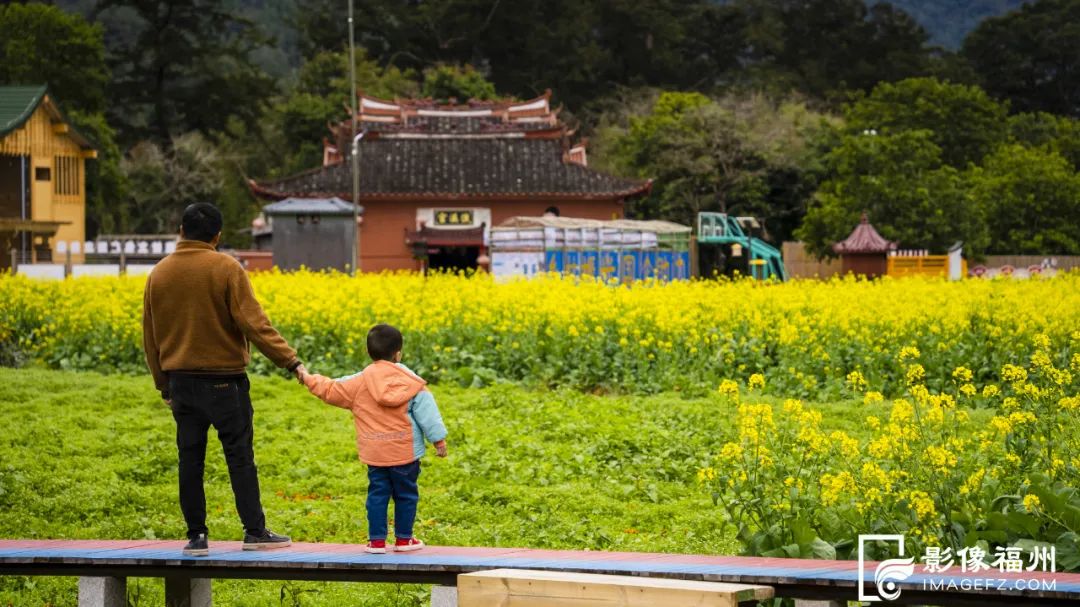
[367,460,420,540]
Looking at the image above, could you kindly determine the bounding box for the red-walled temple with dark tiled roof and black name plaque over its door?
[251,91,651,271]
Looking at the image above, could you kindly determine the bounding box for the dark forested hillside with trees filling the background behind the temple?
[10,0,1080,254]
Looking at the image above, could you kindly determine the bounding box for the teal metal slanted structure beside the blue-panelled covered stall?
[697,212,787,281]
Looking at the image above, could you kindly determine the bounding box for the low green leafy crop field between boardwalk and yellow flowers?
[0,368,881,606]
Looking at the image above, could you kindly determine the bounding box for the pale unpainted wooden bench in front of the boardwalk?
[458,569,773,607]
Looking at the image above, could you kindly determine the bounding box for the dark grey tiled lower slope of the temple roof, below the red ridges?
[252,137,651,200]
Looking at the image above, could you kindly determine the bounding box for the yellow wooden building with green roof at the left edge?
[0,85,97,268]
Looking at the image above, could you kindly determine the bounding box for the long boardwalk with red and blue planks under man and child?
[0,540,1080,606]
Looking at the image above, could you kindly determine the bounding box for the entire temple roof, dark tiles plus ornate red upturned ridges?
[251,92,650,201]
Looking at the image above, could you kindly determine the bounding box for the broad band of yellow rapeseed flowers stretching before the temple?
[0,272,1080,401]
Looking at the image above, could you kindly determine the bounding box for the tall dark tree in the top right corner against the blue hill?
[961,0,1080,118]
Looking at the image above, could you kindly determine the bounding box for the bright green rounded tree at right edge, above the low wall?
[970,144,1080,255]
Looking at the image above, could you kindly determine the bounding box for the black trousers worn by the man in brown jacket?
[168,374,266,538]
